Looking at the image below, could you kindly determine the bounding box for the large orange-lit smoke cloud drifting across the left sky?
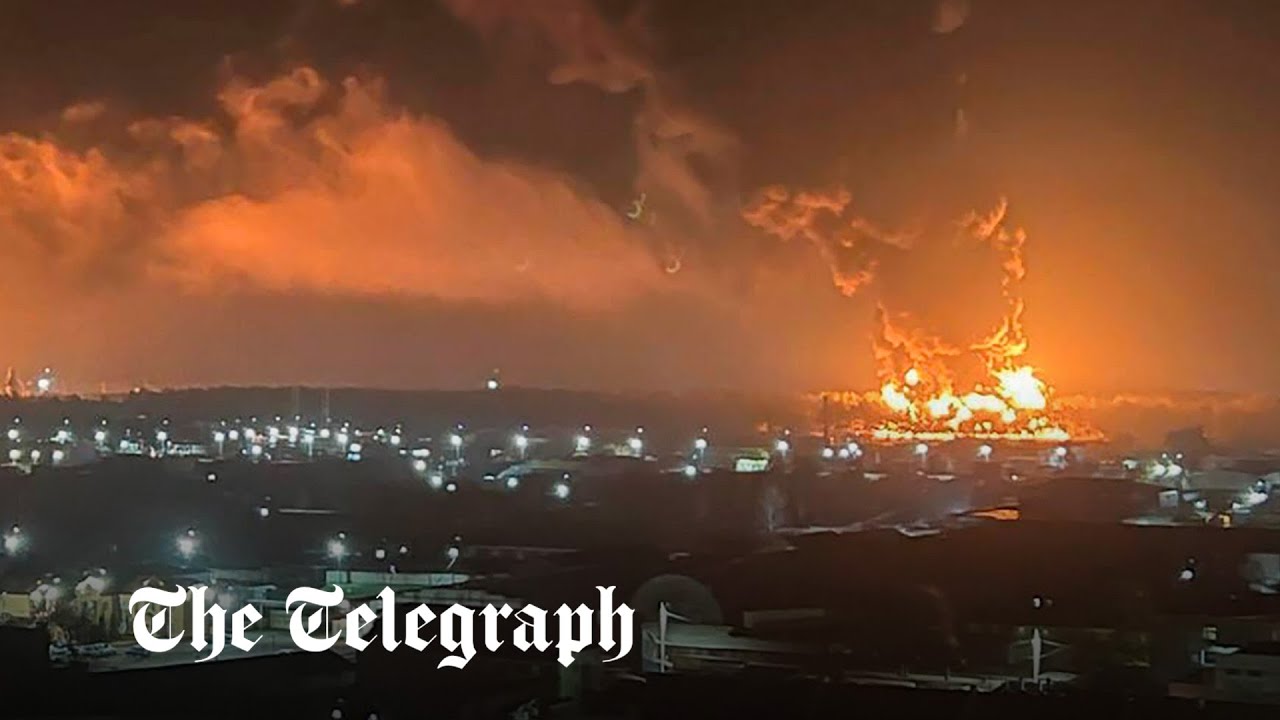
[0,68,663,307]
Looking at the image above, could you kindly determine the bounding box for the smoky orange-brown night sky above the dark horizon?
[0,0,1280,392]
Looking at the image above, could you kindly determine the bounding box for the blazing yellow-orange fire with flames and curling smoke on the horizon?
[744,188,1102,442]
